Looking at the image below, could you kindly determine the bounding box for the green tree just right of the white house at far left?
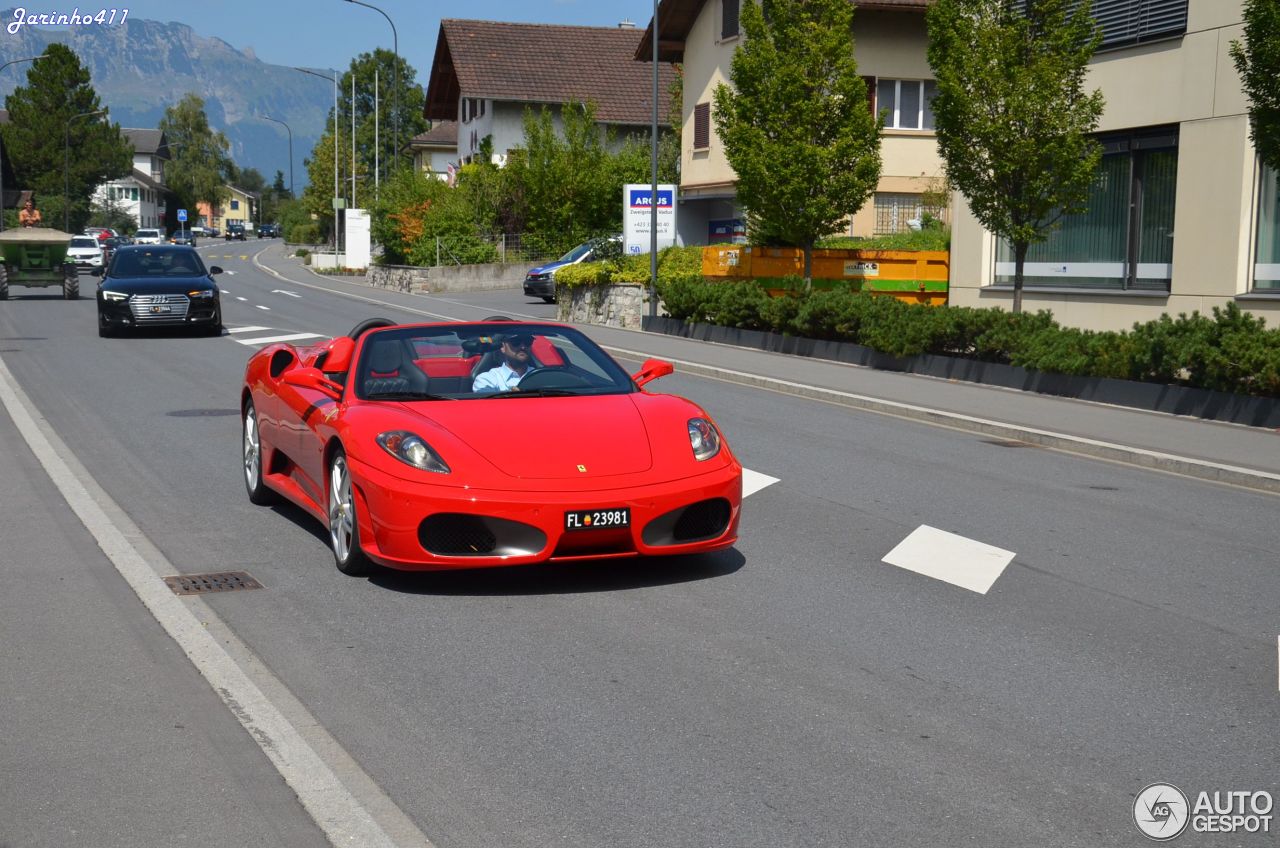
[160,94,236,229]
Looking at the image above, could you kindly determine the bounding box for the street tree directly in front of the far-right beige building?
[927,0,1103,313]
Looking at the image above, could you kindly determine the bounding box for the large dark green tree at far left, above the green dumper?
[0,44,133,232]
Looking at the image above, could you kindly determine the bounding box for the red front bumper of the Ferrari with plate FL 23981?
[348,457,742,571]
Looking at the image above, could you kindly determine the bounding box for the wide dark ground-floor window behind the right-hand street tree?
[996,127,1178,292]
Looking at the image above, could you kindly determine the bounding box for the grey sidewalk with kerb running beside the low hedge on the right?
[252,245,1280,493]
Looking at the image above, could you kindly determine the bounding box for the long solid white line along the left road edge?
[0,357,431,848]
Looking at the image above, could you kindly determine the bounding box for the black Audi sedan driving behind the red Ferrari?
[95,245,223,336]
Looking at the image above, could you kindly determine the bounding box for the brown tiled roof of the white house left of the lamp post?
[424,19,676,124]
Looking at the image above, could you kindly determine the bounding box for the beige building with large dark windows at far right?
[951,0,1280,329]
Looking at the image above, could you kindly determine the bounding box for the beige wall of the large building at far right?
[951,0,1280,329]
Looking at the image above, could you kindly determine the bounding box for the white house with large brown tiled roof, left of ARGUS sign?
[422,19,676,166]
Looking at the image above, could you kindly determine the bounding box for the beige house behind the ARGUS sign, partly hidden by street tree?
[635,0,942,245]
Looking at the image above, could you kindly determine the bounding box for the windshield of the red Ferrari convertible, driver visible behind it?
[355,322,636,402]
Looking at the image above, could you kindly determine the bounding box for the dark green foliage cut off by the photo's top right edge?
[1231,0,1280,179]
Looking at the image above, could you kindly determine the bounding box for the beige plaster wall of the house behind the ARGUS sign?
[680,1,942,243]
